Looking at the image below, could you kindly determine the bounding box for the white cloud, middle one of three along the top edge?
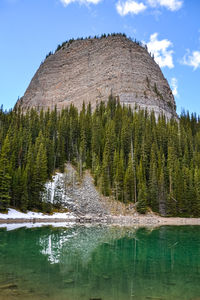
[116,0,147,16]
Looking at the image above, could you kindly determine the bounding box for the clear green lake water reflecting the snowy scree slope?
[0,226,200,300]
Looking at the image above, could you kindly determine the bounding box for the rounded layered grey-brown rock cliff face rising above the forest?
[18,35,176,117]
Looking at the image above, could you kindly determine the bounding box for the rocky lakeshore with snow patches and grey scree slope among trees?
[0,163,200,227]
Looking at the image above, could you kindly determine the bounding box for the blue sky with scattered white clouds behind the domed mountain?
[0,0,200,115]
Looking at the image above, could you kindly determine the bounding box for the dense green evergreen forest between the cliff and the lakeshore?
[0,96,200,217]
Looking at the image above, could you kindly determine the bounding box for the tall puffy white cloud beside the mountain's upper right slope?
[147,33,174,69]
